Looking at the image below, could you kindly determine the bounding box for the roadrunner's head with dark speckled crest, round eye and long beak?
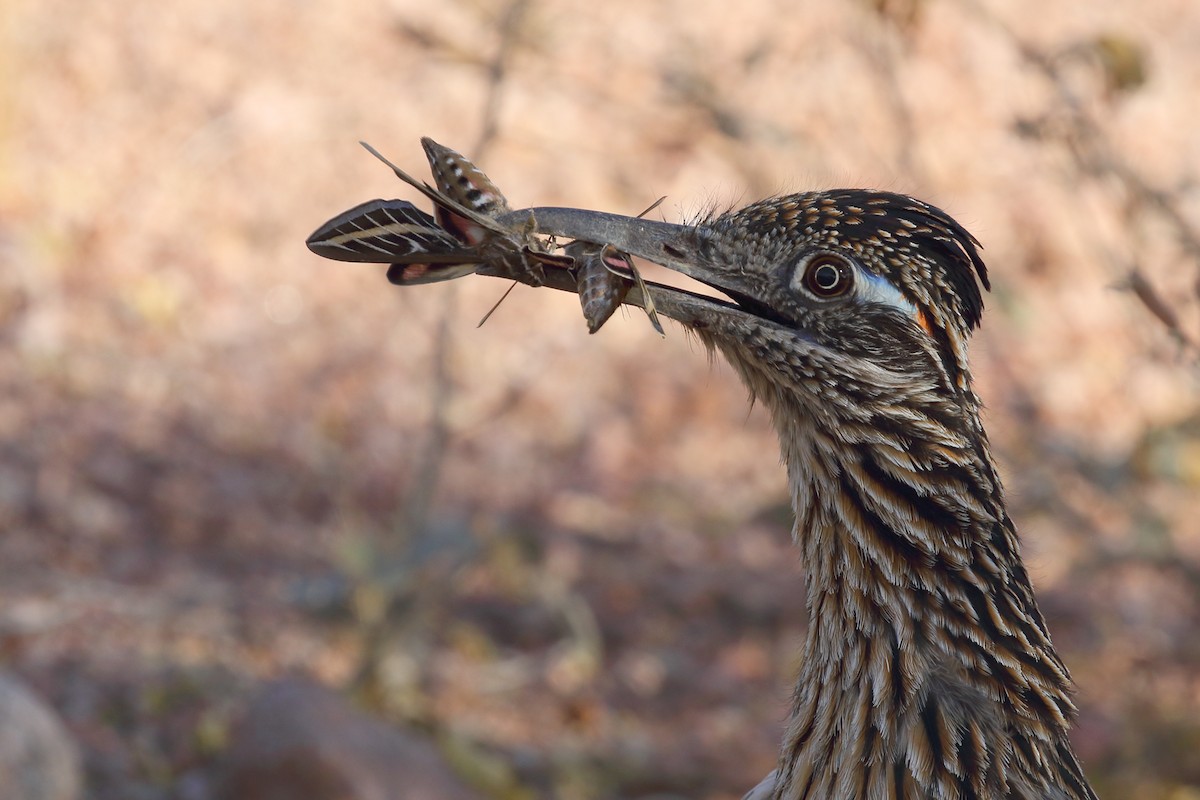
[504,190,988,419]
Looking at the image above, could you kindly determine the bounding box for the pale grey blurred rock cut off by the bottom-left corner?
[0,674,83,800]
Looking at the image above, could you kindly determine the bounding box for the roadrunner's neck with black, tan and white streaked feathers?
[768,396,1090,798]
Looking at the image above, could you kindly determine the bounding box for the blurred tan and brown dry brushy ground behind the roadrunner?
[0,0,1200,800]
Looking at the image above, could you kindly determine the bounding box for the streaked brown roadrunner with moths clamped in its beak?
[314,149,1096,800]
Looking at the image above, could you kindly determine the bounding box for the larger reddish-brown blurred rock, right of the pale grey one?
[216,680,482,800]
